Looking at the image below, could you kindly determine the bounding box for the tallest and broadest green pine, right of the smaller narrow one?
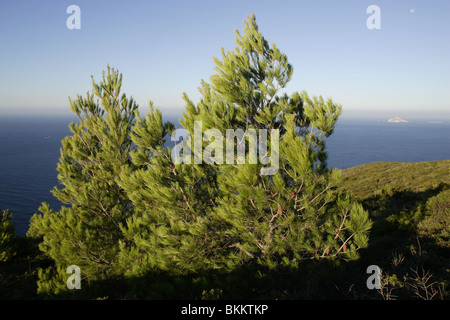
[117,15,371,282]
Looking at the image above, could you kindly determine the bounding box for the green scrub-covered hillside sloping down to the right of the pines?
[339,160,450,299]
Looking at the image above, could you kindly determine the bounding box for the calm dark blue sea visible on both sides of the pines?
[0,116,450,235]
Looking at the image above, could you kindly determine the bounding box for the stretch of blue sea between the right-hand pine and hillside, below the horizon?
[327,119,450,169]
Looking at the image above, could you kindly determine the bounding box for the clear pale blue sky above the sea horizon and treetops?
[0,0,450,119]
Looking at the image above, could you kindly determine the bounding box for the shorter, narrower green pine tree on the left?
[27,66,137,292]
